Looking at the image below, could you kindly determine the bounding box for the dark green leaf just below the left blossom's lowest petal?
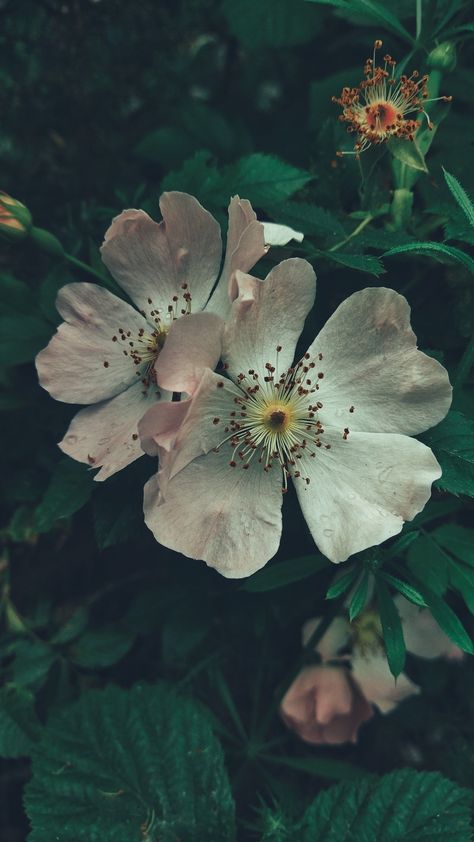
[35,458,94,532]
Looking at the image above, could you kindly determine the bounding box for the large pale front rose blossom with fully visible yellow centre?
[140,258,451,578]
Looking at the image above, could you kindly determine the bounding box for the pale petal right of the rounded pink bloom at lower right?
[352,649,420,713]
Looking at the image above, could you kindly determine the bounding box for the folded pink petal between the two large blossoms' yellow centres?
[155,313,224,394]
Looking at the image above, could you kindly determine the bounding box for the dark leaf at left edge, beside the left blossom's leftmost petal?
[0,313,51,365]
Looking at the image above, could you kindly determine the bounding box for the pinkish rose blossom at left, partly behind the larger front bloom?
[36,192,302,480]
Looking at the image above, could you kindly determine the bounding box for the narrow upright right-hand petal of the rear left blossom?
[206,196,268,318]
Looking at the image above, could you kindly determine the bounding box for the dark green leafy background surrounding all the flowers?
[0,0,474,842]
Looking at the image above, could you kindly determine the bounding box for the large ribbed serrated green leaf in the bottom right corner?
[266,769,471,842]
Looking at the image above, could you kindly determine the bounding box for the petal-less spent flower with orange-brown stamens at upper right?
[332,40,452,156]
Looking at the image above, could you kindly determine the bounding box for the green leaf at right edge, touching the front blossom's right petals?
[420,411,474,497]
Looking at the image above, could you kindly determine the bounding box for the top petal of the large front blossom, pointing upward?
[222,257,316,377]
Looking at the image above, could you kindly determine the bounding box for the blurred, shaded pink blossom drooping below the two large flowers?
[280,596,463,744]
